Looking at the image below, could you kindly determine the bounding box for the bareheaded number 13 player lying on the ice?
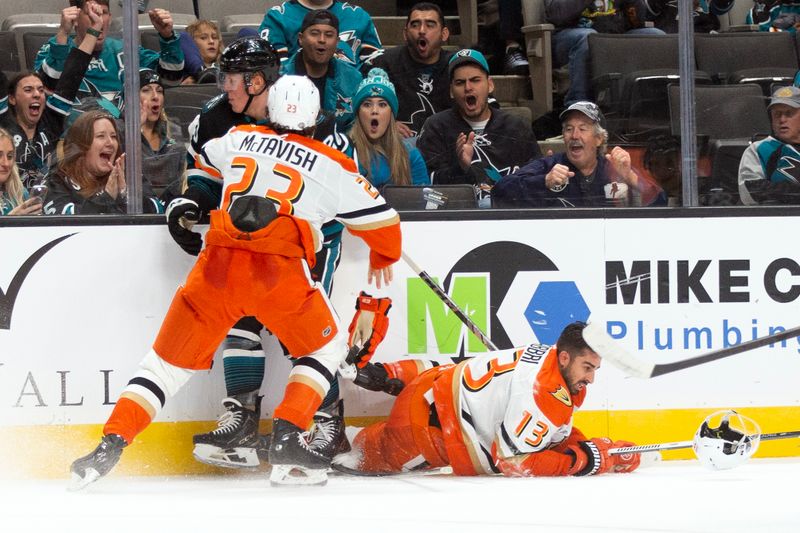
[334,322,639,476]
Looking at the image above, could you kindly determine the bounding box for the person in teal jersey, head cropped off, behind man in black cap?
[258,0,383,68]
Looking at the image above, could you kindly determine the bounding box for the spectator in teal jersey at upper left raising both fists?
[34,0,183,108]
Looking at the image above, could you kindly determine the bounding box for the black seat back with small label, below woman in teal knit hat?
[381,184,478,211]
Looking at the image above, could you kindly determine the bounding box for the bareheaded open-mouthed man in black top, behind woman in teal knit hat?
[367,2,453,137]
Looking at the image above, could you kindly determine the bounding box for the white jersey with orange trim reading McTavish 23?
[195,125,401,268]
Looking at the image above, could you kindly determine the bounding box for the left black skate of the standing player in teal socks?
[192,396,261,468]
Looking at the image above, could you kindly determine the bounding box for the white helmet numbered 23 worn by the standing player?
[267,76,319,132]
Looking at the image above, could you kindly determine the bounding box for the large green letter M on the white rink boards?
[406,274,489,355]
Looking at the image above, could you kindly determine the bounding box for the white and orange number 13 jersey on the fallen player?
[435,344,586,474]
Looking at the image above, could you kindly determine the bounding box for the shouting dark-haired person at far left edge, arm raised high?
[0,3,109,189]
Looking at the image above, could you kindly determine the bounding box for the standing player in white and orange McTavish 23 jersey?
[71,76,401,488]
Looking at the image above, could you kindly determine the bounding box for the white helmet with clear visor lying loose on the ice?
[692,410,761,470]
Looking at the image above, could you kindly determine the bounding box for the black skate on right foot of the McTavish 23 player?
[269,418,331,486]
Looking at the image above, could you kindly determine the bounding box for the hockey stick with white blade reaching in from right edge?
[583,321,800,378]
